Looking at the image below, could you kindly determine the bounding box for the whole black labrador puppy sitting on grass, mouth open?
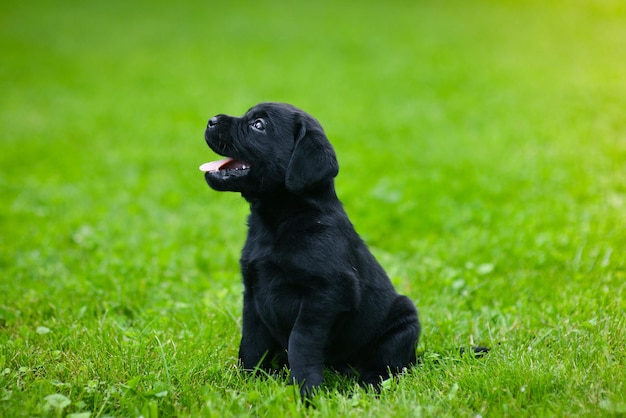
[200,103,420,396]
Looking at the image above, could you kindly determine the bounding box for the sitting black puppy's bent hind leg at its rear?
[359,295,420,389]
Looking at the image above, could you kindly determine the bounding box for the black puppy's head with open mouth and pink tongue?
[200,103,339,196]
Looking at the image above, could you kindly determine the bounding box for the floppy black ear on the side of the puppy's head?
[285,116,339,193]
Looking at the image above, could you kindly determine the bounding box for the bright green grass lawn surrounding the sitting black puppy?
[0,0,626,418]
